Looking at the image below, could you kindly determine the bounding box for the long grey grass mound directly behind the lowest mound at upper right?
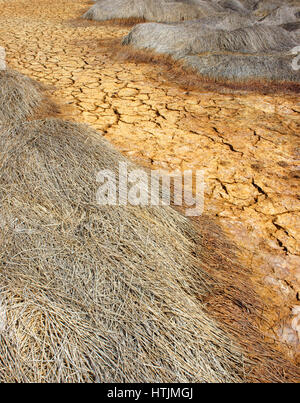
[122,21,297,59]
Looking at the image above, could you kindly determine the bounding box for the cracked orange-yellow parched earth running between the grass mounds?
[0,0,300,359]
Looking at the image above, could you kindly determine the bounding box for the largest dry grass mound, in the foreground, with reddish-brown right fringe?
[0,119,299,382]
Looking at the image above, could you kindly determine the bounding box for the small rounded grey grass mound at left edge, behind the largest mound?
[0,69,45,128]
